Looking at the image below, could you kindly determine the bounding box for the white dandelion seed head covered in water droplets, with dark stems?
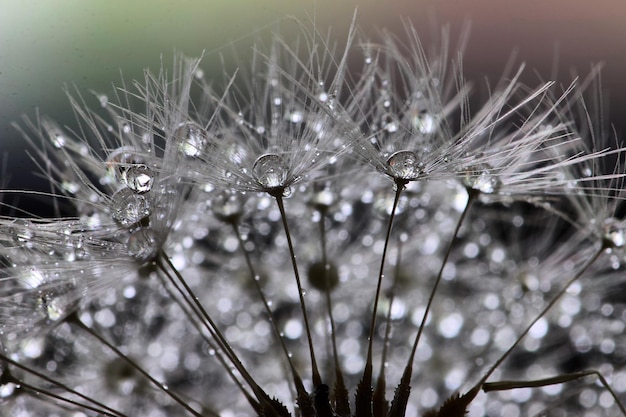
[0,17,626,417]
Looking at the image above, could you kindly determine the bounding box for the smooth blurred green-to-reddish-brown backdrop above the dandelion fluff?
[0,0,626,202]
